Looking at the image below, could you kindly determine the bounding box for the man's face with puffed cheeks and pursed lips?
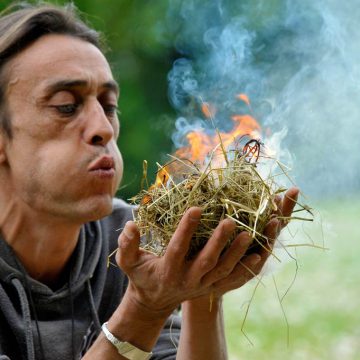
[1,35,123,222]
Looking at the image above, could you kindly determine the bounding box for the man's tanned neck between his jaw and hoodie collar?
[0,198,81,286]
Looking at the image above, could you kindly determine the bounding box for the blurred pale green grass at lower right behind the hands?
[224,198,360,360]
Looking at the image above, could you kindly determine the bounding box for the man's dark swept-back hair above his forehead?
[0,3,102,138]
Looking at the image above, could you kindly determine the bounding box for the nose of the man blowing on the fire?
[84,101,114,146]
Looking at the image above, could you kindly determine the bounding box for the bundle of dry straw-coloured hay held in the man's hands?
[131,140,285,259]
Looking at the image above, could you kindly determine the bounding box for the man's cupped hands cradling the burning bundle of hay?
[116,188,298,317]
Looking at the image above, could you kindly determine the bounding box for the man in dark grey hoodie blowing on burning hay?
[0,2,298,360]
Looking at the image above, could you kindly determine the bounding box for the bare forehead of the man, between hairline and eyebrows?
[9,34,118,90]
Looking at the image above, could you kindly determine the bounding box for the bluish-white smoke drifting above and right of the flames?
[167,0,360,197]
